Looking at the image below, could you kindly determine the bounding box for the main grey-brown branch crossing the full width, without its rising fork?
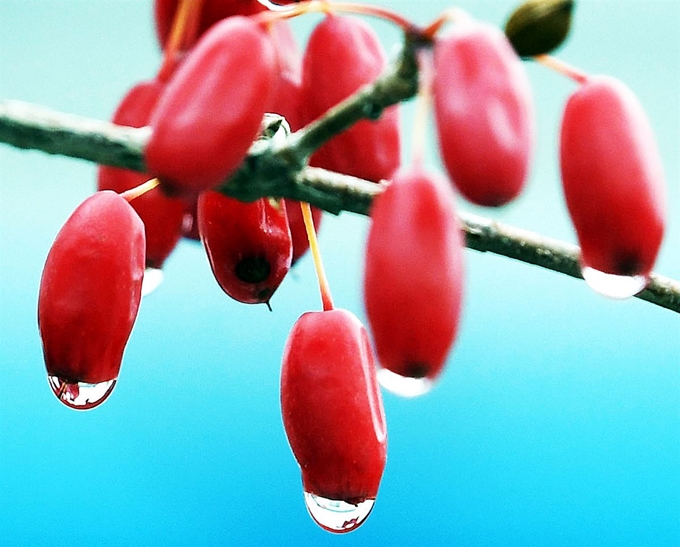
[0,97,680,313]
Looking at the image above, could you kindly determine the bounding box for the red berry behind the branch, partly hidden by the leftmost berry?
[97,80,188,269]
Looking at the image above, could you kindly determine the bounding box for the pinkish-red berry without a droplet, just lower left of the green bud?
[433,21,534,206]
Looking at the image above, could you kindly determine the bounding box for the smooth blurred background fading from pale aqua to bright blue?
[0,0,680,546]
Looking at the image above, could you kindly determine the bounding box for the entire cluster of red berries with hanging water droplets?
[38,0,664,532]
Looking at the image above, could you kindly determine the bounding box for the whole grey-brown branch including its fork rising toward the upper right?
[0,40,680,313]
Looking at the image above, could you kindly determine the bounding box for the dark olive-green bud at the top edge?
[505,0,574,57]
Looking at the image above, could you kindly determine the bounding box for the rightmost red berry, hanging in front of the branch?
[560,76,666,296]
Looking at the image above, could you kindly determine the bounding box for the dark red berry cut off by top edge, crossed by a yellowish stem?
[154,0,267,49]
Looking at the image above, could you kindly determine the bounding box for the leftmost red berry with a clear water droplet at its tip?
[38,190,144,409]
